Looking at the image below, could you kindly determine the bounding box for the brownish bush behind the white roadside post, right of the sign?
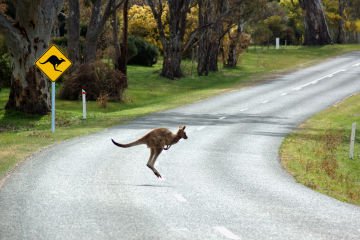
[59,61,126,100]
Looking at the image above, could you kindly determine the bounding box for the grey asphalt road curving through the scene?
[0,52,360,240]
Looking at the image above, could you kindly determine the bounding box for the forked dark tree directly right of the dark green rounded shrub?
[147,0,192,79]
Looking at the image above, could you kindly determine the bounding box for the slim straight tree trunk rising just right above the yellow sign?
[67,0,80,65]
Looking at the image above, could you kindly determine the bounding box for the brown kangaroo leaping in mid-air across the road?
[111,126,188,178]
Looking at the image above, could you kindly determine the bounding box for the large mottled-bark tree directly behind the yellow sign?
[0,0,63,114]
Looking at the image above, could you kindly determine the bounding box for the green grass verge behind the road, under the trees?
[0,45,360,178]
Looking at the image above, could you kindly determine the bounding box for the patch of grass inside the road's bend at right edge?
[280,95,360,205]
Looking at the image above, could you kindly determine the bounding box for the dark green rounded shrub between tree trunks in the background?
[128,36,159,66]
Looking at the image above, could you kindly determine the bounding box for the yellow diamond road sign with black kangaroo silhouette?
[35,45,72,82]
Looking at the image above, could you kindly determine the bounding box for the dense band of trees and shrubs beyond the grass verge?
[0,0,360,114]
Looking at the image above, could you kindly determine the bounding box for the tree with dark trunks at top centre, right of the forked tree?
[197,0,265,71]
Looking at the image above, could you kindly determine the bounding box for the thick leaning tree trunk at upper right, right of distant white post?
[299,0,332,45]
